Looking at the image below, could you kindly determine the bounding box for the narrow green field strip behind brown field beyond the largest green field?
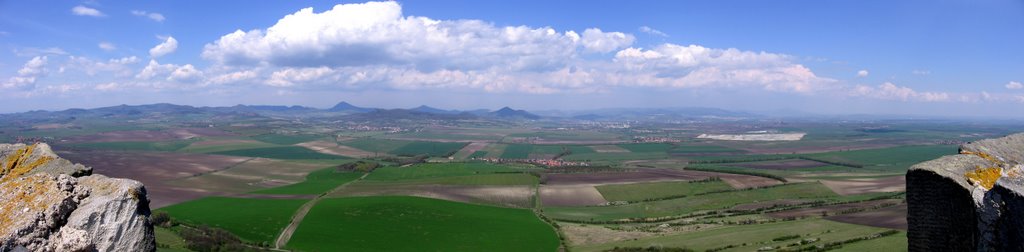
[367,162,524,180]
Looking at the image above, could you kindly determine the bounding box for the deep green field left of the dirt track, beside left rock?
[160,197,307,244]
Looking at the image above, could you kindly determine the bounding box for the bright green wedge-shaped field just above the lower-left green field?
[253,167,364,195]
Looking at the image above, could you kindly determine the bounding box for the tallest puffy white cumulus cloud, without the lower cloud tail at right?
[202,2,633,72]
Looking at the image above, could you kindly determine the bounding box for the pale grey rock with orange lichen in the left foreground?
[0,143,156,251]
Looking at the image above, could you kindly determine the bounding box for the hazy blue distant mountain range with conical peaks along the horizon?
[0,101,759,121]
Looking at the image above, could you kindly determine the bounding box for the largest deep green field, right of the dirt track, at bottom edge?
[287,197,559,251]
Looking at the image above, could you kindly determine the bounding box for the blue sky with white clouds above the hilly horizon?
[0,0,1024,119]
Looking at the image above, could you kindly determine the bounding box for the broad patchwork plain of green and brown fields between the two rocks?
[18,112,1001,251]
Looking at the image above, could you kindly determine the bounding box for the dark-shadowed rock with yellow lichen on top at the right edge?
[906,133,1024,251]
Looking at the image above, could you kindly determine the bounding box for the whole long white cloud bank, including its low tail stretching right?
[193,2,835,93]
